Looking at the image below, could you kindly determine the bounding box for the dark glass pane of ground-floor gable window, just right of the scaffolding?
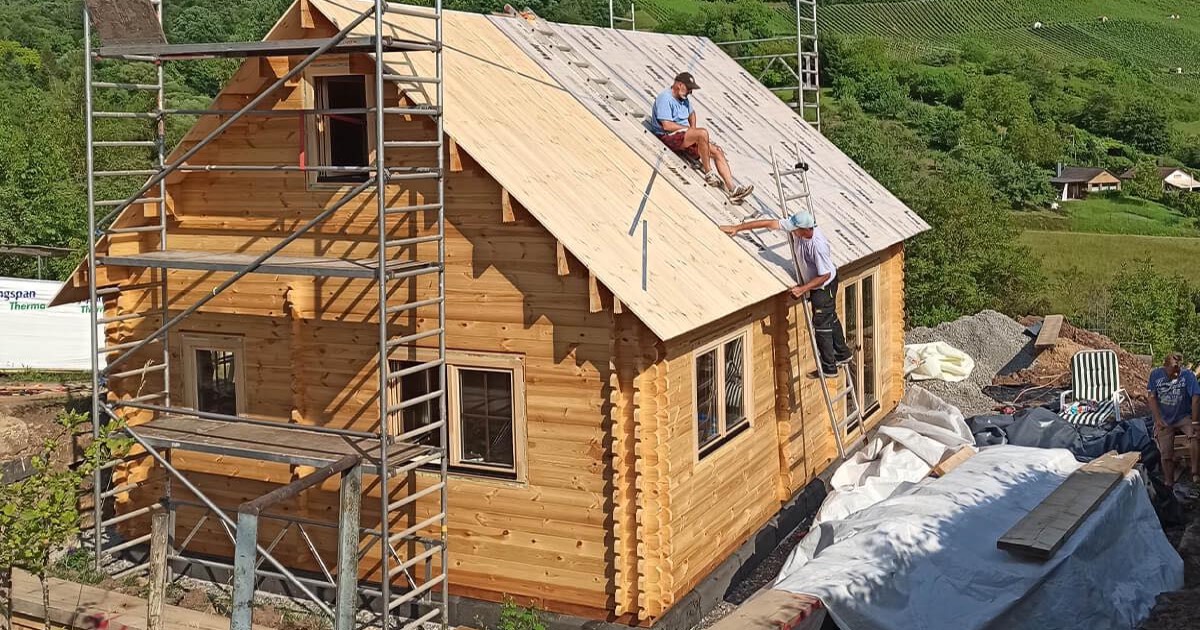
[457,367,515,469]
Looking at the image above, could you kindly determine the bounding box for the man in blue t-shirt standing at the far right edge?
[1146,353,1200,486]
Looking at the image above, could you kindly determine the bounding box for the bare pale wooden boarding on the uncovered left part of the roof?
[311,0,788,340]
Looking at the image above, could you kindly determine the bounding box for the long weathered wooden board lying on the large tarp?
[996,451,1139,560]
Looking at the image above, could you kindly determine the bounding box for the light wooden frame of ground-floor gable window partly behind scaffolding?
[388,348,528,484]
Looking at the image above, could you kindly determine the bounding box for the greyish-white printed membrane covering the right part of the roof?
[490,16,929,277]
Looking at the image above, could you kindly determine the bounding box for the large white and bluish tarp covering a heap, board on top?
[774,446,1183,630]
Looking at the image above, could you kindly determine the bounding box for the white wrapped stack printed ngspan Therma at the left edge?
[0,277,98,370]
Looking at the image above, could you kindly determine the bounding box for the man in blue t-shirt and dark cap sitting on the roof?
[650,72,754,204]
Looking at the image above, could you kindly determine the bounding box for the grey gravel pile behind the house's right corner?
[905,311,1034,418]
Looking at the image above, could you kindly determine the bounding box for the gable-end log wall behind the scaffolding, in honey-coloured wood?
[100,16,636,618]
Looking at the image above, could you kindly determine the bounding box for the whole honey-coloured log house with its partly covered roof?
[56,0,926,626]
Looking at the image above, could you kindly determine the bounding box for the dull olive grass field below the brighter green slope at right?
[1021,229,1200,312]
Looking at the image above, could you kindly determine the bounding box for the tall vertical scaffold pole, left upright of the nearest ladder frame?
[369,0,393,630]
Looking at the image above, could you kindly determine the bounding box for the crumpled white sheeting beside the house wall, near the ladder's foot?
[816,388,974,523]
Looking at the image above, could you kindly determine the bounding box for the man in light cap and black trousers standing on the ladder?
[721,211,854,378]
